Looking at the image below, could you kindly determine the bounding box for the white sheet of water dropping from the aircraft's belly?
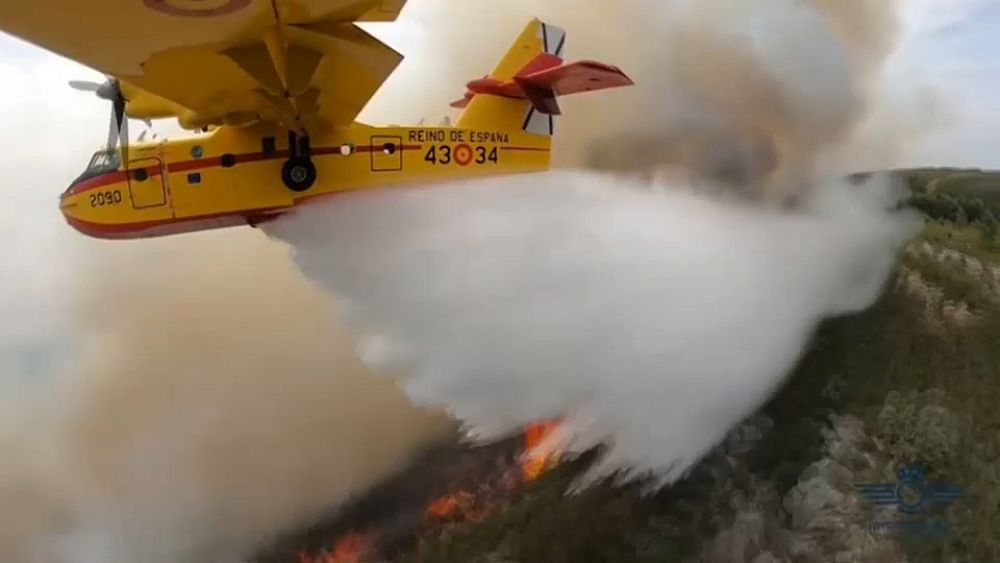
[269,171,913,479]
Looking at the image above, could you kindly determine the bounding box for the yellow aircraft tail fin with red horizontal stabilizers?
[452,20,632,135]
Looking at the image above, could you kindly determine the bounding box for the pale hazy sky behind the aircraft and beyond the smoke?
[0,0,1000,386]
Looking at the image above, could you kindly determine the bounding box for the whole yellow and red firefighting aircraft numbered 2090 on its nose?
[0,0,632,238]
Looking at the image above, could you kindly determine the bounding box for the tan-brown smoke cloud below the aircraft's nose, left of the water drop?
[0,232,449,563]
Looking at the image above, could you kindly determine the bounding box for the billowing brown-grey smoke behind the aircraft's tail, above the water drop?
[374,0,899,201]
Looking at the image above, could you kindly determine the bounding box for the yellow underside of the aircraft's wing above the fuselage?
[0,0,406,128]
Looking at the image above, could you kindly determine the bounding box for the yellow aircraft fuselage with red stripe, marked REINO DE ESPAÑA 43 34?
[60,123,550,239]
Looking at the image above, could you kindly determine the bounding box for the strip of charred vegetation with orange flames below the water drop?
[254,420,559,563]
